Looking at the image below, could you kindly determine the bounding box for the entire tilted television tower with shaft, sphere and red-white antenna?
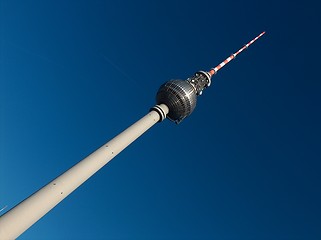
[0,32,265,240]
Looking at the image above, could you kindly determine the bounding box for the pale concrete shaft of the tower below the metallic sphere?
[0,104,168,240]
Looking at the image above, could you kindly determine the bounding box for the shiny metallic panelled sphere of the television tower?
[156,80,197,123]
